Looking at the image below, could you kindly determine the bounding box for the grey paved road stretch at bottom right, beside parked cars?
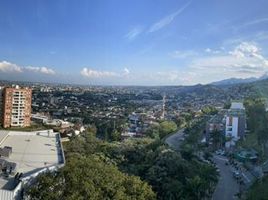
[212,155,239,200]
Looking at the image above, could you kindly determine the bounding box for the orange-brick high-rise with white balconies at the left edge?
[2,86,32,128]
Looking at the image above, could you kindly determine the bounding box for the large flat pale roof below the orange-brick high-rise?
[0,130,64,189]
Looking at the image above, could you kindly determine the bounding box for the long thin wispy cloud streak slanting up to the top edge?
[148,1,191,33]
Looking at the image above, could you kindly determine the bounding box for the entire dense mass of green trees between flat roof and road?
[27,112,217,200]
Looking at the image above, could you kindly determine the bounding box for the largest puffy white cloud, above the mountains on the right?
[190,42,268,82]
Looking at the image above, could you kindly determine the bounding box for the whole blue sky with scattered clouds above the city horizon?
[0,0,268,85]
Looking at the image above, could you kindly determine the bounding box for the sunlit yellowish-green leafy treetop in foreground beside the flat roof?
[26,156,156,200]
